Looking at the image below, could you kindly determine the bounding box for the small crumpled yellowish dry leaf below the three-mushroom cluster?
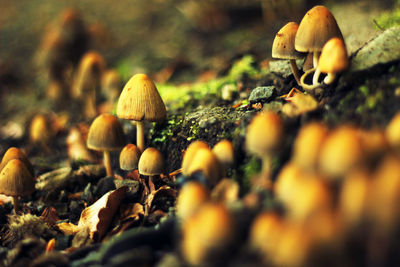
[282,93,318,117]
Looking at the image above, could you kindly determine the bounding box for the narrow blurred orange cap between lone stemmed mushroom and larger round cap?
[292,122,328,170]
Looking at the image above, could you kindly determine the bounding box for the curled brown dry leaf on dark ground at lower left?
[78,186,128,241]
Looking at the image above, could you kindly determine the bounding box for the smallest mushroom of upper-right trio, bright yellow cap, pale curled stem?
[300,37,349,90]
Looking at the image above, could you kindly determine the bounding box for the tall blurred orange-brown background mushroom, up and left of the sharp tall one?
[73,52,105,118]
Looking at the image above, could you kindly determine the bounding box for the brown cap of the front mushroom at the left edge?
[0,159,35,197]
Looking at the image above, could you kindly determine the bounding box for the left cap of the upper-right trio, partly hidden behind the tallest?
[272,22,304,59]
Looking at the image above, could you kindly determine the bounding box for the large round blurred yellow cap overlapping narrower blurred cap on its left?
[319,126,364,179]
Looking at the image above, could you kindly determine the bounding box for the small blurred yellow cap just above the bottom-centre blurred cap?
[176,182,209,220]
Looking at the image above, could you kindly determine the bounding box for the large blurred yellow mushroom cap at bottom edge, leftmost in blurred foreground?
[181,203,233,265]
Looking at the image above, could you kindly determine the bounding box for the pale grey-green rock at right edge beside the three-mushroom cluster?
[351,26,400,71]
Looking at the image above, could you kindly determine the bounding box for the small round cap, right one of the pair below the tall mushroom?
[139,147,165,176]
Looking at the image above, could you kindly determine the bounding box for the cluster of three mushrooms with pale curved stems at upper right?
[272,6,349,92]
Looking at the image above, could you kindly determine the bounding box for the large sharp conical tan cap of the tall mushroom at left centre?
[117,74,167,122]
